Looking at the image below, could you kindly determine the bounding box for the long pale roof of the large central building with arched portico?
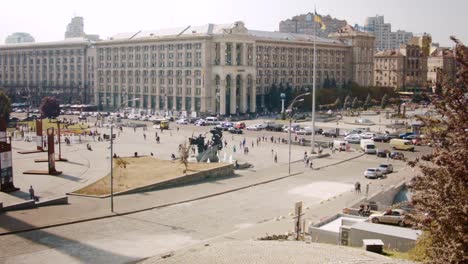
[106,21,343,45]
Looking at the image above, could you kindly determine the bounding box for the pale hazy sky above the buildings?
[0,0,468,46]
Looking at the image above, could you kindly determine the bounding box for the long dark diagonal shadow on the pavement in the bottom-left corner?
[0,214,138,263]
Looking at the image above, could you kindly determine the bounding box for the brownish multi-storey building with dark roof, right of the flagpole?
[374,45,427,90]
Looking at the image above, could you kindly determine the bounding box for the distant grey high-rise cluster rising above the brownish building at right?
[364,15,413,50]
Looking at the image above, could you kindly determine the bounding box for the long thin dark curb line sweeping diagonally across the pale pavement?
[0,154,365,236]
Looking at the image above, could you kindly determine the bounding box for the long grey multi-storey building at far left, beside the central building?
[0,38,94,106]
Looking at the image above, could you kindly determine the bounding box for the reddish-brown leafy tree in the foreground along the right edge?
[409,38,468,263]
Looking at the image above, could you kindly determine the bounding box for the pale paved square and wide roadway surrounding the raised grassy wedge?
[0,112,426,263]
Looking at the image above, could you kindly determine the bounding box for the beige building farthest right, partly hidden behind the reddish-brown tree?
[427,48,456,86]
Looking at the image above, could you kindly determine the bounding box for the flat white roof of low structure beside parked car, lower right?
[351,222,422,240]
